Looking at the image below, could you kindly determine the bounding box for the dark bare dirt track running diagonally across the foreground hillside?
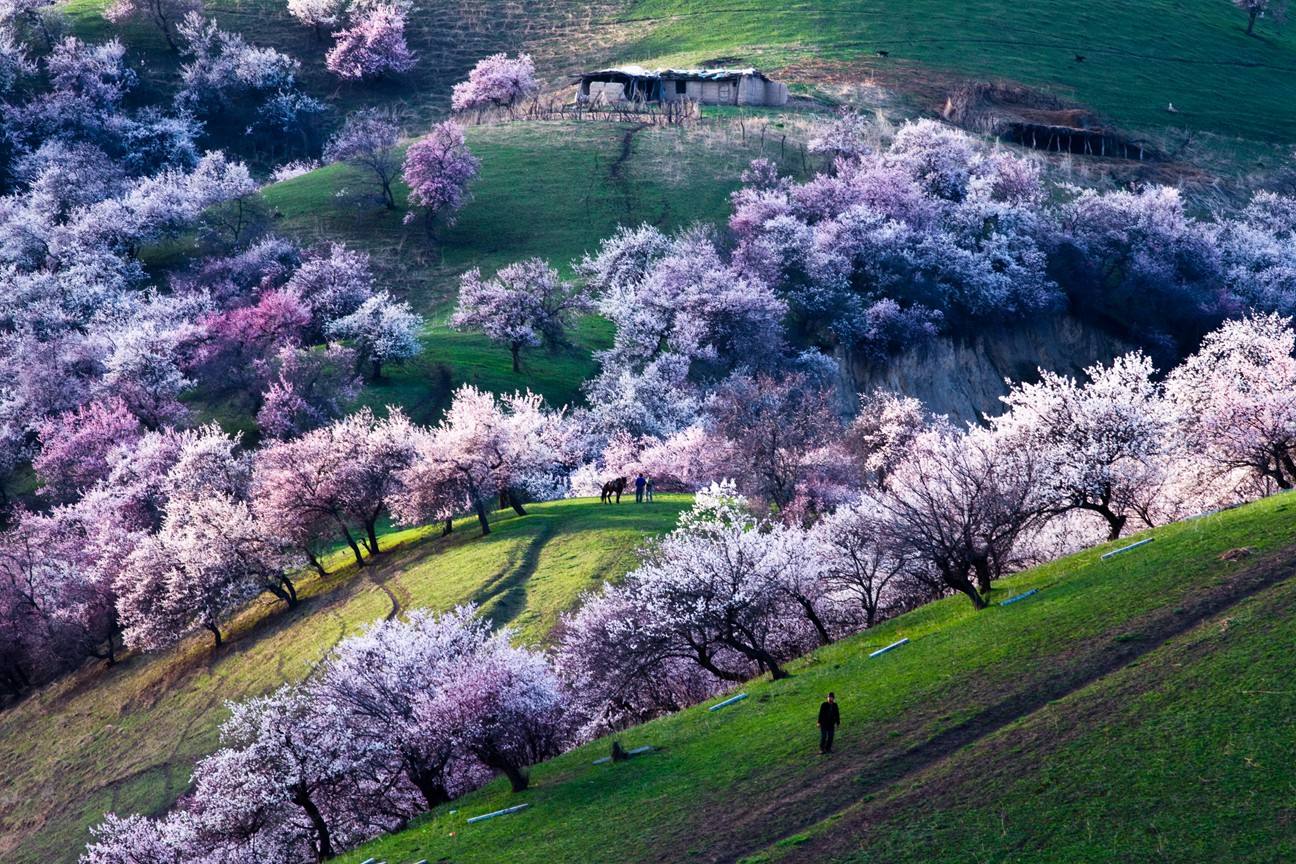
[679,549,1296,861]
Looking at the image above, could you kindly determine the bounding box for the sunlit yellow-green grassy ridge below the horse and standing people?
[0,495,686,864]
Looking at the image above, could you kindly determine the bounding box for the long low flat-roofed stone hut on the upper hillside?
[578,66,788,105]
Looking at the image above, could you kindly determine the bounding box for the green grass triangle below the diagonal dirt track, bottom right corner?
[789,580,1296,864]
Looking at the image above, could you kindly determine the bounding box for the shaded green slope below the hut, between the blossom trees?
[251,115,801,422]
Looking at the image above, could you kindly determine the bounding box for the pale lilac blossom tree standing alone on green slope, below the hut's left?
[450,258,594,372]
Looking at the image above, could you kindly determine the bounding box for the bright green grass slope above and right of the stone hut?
[618,0,1296,142]
